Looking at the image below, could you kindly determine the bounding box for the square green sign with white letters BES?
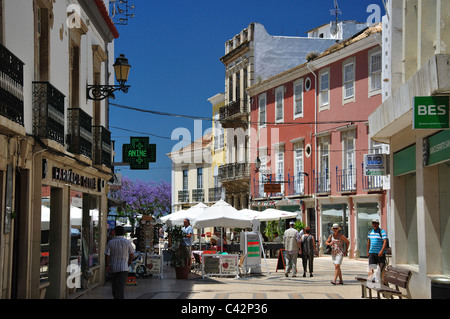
[413,96,450,129]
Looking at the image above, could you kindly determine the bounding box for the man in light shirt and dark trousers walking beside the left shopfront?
[105,226,134,299]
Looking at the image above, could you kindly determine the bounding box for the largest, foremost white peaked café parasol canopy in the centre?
[193,199,253,228]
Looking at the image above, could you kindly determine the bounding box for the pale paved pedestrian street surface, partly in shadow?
[78,256,367,300]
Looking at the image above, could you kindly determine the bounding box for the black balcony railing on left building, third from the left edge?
[67,108,93,159]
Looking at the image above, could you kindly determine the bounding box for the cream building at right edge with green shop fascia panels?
[369,0,450,298]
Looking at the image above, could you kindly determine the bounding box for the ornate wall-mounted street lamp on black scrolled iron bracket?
[86,54,131,101]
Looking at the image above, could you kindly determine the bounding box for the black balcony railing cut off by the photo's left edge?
[0,44,24,126]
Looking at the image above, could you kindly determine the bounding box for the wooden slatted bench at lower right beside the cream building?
[355,266,412,299]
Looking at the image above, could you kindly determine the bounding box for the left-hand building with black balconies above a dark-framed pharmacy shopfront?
[0,0,118,299]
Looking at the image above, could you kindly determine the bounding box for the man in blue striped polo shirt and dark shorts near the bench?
[367,219,388,279]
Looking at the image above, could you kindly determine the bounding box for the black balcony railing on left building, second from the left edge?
[33,82,65,145]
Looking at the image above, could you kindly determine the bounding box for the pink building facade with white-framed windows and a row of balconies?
[248,26,389,258]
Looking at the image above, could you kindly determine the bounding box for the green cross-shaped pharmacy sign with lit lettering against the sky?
[122,137,156,169]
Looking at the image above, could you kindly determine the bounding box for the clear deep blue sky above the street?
[110,0,384,182]
